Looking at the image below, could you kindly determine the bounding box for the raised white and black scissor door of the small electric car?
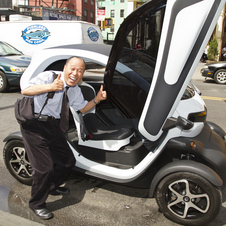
[105,0,225,141]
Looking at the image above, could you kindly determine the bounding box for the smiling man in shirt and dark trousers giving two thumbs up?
[21,57,107,219]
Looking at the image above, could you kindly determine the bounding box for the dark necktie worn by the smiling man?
[60,86,69,133]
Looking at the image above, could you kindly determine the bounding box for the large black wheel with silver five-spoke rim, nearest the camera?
[156,172,222,226]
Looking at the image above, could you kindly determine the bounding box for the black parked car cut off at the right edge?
[201,61,226,84]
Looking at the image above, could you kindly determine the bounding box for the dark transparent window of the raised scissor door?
[105,1,165,118]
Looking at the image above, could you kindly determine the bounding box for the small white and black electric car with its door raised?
[4,0,226,225]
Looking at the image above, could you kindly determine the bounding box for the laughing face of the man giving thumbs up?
[64,58,85,86]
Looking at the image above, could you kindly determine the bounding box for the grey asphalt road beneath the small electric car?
[0,65,226,226]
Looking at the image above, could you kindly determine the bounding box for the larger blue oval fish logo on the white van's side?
[21,24,50,45]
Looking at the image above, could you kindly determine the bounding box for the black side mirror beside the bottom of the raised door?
[162,116,194,131]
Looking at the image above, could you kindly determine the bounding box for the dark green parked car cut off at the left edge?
[0,41,31,92]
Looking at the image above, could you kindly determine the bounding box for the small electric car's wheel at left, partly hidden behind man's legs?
[3,140,33,185]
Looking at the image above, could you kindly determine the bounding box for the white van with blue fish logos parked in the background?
[0,20,103,56]
